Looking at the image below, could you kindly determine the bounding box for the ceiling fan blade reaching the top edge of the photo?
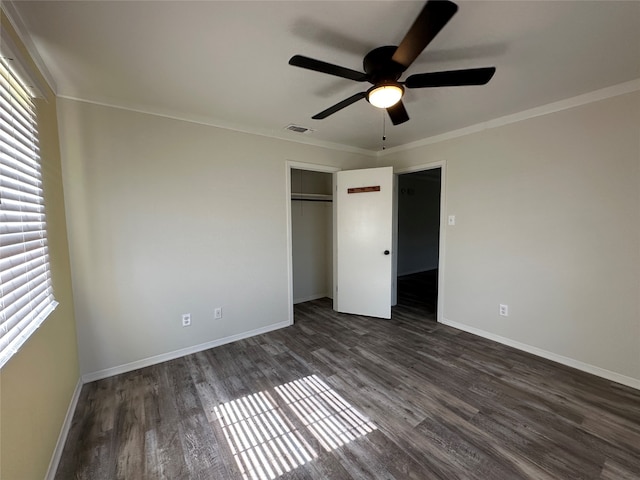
[391,0,458,70]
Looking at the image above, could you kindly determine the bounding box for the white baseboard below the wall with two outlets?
[82,322,289,383]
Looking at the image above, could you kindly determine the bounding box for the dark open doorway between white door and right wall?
[395,168,441,321]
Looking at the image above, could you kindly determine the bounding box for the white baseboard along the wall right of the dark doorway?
[440,318,640,390]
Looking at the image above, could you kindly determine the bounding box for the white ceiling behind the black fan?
[10,0,640,151]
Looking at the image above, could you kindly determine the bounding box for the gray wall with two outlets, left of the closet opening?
[59,99,372,378]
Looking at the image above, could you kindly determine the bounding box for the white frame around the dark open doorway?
[392,160,447,323]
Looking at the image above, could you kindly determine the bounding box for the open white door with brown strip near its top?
[334,167,393,319]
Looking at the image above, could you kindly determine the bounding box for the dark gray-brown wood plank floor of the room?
[56,299,640,480]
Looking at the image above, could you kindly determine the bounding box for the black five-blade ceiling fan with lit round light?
[289,0,496,125]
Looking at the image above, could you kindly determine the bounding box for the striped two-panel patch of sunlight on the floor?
[214,375,376,480]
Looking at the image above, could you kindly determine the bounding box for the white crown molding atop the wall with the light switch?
[378,79,640,157]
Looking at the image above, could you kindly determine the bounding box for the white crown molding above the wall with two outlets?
[58,94,377,158]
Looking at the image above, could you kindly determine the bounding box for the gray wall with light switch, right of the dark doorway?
[380,91,640,388]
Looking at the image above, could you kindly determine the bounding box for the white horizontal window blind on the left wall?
[0,58,57,368]
